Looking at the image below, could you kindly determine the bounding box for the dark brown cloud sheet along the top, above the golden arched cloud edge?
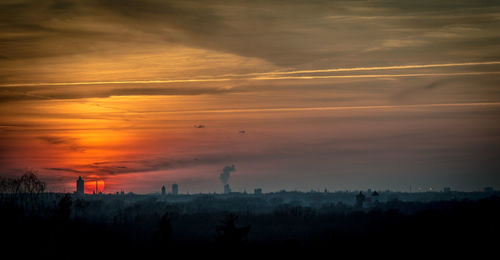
[0,0,499,74]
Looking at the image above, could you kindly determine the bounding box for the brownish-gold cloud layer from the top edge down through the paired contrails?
[0,0,500,108]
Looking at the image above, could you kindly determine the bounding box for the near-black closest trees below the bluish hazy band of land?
[0,195,500,256]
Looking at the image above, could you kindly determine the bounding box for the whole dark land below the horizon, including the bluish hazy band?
[0,193,500,259]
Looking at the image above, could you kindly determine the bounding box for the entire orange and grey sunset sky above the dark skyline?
[0,0,500,193]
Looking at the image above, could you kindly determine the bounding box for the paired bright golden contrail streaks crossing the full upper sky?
[0,61,500,102]
